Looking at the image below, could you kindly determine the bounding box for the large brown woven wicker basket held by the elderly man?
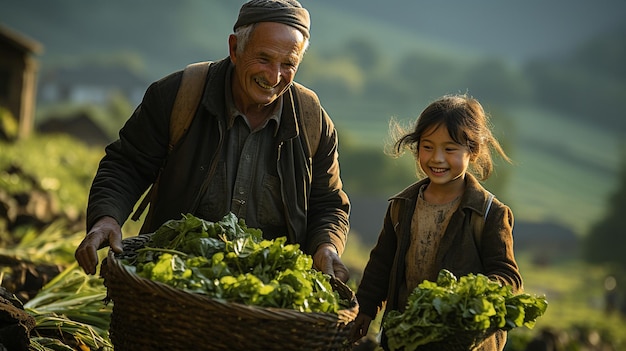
[102,235,358,351]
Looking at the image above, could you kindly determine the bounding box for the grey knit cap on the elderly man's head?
[233,0,311,38]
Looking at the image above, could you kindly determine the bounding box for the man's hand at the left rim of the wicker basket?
[74,216,123,274]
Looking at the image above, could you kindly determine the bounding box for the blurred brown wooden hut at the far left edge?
[0,25,43,138]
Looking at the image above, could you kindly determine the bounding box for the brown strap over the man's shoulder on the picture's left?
[169,61,211,151]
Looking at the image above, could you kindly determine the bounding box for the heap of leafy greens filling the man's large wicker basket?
[121,213,345,313]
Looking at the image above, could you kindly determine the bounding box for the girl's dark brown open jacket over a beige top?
[356,173,522,350]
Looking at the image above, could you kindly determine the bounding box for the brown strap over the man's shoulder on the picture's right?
[293,82,322,157]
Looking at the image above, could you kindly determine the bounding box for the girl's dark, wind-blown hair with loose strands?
[391,94,511,180]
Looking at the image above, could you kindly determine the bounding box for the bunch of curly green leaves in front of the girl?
[383,269,548,351]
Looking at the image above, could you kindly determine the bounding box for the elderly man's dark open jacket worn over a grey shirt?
[87,58,350,254]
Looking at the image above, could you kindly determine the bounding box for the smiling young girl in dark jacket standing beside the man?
[351,95,522,351]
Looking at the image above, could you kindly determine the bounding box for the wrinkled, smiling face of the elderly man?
[229,22,305,110]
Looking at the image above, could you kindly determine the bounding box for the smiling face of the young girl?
[418,125,470,185]
